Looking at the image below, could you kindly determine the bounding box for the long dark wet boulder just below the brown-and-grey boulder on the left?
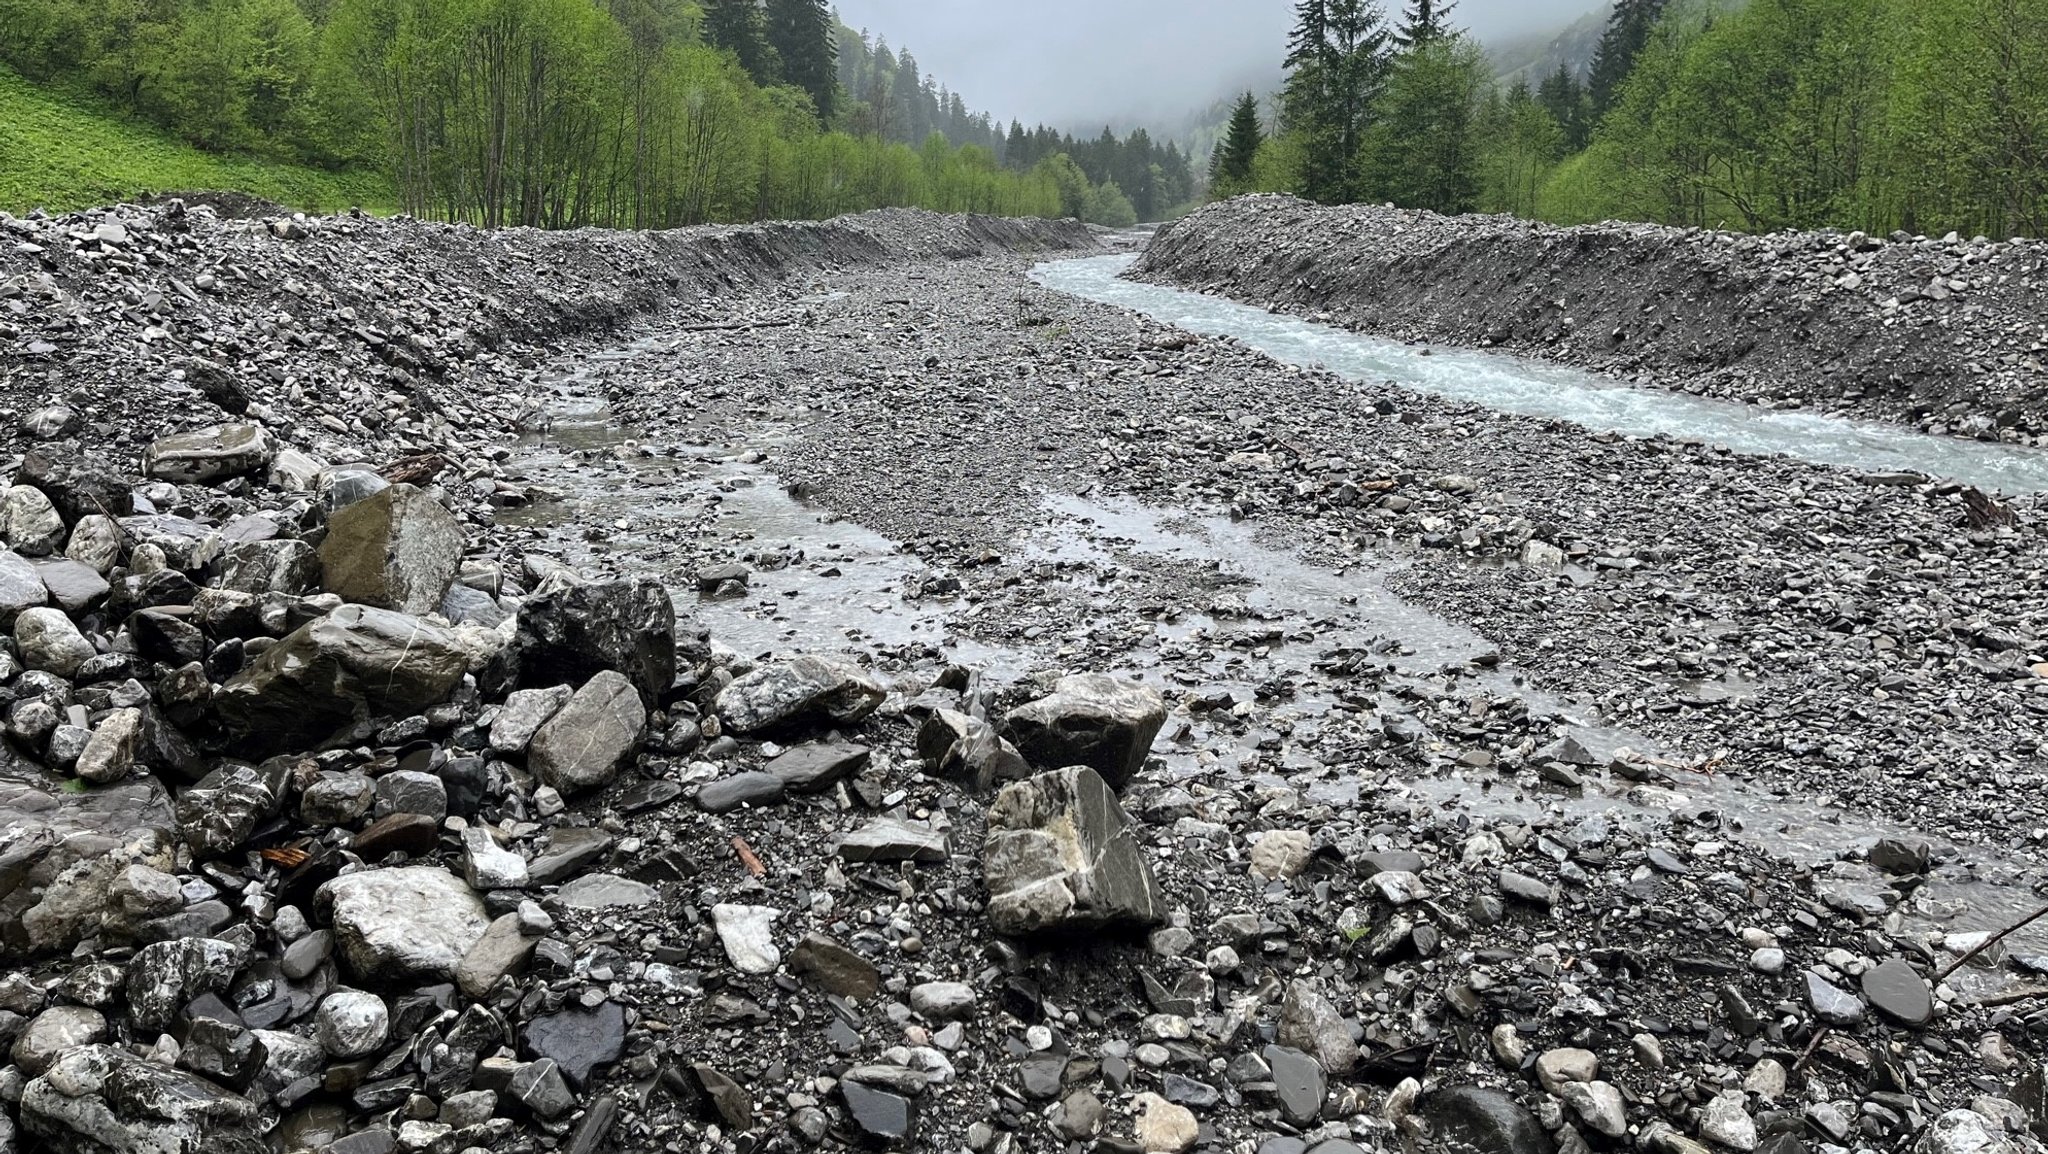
[215,605,469,752]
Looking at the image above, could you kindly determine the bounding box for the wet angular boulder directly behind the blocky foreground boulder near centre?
[1006,672,1165,789]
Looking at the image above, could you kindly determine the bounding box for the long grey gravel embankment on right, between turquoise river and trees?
[1133,197,2048,443]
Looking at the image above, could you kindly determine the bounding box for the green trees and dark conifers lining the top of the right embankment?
[1210,0,2048,236]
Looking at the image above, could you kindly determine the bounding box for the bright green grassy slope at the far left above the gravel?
[0,68,393,213]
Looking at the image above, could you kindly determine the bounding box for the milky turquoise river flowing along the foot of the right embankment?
[1032,254,2048,492]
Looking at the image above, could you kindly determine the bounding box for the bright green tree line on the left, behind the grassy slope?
[0,0,1171,228]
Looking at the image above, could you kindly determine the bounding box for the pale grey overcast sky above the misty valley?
[836,0,1599,129]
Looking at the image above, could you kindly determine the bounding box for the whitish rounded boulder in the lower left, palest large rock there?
[315,865,492,982]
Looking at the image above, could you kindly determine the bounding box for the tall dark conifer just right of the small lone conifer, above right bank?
[1280,0,1391,203]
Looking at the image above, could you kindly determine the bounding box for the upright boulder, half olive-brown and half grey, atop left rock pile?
[319,486,467,617]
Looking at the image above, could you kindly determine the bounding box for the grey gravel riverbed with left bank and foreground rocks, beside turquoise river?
[0,207,2048,1154]
